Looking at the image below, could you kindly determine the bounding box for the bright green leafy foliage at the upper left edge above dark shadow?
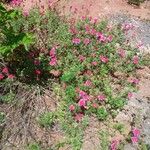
[0,4,33,56]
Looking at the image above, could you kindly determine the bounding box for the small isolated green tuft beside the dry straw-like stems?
[37,112,54,128]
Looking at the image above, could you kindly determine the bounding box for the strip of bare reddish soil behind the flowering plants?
[19,0,150,19]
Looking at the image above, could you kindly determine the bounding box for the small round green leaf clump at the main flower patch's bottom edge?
[97,107,108,120]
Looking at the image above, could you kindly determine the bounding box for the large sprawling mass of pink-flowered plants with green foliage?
[0,2,141,149]
